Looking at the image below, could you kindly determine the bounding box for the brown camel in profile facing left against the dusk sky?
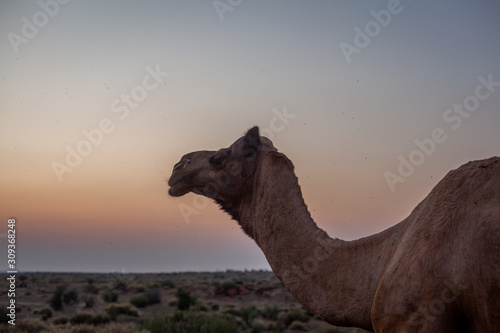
[168,127,500,333]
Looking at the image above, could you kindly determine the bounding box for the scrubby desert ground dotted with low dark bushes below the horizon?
[0,270,364,333]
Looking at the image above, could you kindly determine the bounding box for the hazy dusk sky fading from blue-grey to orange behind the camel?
[0,0,500,272]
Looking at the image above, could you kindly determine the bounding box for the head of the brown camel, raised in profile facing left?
[168,127,276,217]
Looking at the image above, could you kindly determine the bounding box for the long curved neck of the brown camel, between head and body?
[239,153,404,330]
